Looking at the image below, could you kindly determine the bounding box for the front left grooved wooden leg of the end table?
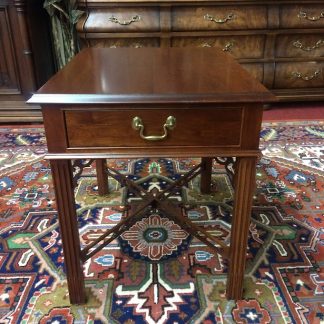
[51,160,86,304]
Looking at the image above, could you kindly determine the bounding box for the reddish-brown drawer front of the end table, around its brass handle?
[65,108,243,148]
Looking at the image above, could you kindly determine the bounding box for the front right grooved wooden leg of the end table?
[226,157,256,300]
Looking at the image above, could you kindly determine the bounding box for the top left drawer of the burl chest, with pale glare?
[83,7,160,33]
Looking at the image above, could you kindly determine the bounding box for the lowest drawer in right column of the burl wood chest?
[274,62,324,88]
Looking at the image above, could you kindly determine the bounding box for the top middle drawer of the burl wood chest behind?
[171,6,267,31]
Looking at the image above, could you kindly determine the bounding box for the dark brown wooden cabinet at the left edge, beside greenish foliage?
[0,0,54,122]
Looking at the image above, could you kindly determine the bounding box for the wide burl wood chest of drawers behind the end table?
[77,0,324,101]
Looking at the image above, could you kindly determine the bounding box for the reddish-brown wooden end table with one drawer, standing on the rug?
[29,48,275,304]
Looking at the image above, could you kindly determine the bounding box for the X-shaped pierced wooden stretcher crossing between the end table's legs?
[81,163,229,262]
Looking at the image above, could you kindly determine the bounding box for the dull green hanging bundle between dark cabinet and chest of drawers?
[44,0,84,69]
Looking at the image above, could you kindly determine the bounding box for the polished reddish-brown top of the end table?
[29,48,276,104]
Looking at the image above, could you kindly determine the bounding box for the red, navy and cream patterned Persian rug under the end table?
[0,121,324,324]
